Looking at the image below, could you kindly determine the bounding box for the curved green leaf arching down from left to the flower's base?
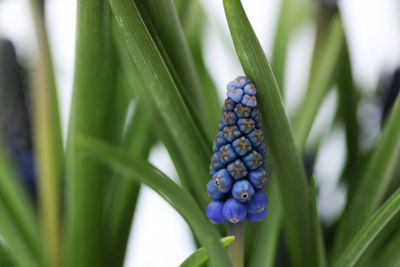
[76,136,231,266]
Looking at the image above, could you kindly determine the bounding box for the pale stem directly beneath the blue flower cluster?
[228,221,244,267]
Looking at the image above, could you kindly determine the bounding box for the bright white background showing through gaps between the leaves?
[0,0,400,266]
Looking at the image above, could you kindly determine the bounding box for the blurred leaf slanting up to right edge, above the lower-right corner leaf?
[333,89,400,258]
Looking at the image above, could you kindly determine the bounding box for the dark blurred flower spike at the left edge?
[0,40,37,199]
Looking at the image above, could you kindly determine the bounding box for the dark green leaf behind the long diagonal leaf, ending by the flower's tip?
[135,0,212,137]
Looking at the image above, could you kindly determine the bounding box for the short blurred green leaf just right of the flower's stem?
[246,178,283,267]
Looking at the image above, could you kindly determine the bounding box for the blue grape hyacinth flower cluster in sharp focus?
[207,76,268,224]
